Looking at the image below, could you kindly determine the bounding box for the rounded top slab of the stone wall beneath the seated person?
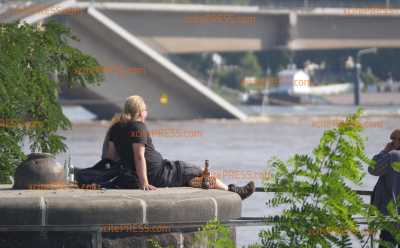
[0,185,241,225]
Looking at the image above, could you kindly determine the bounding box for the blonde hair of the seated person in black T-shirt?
[111,95,146,126]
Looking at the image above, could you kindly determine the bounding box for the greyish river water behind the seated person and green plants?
[50,116,399,247]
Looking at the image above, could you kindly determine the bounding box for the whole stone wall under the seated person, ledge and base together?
[0,185,241,248]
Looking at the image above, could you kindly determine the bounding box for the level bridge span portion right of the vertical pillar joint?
[286,9,400,50]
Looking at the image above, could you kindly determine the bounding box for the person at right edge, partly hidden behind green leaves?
[368,129,400,247]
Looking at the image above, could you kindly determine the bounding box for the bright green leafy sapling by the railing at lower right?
[261,110,372,248]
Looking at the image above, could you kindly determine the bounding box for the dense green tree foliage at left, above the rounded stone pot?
[0,21,103,183]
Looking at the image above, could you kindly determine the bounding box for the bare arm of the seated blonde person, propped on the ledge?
[132,143,157,190]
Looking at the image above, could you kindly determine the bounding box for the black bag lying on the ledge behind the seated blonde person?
[75,159,139,189]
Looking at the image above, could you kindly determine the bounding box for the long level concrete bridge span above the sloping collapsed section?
[75,2,400,53]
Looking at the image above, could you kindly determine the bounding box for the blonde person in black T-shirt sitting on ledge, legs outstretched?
[102,95,255,199]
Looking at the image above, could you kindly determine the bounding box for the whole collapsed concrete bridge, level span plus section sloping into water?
[4,0,400,120]
